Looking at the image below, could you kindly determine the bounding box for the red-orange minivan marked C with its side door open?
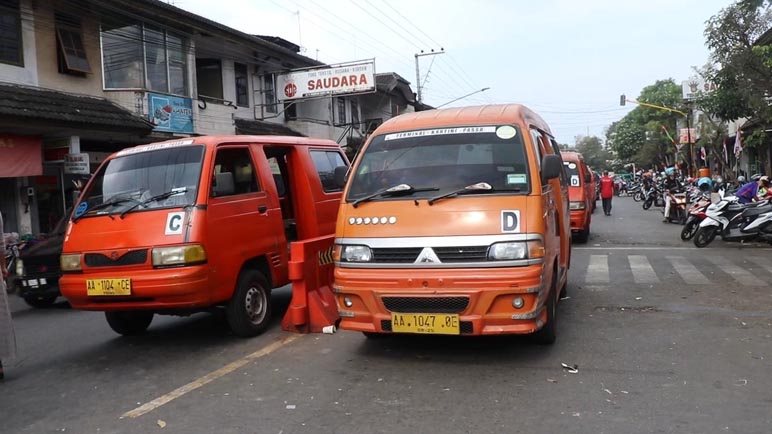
[60,136,348,336]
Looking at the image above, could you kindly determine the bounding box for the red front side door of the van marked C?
[206,144,286,302]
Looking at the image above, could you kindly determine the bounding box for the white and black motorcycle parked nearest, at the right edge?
[694,198,772,247]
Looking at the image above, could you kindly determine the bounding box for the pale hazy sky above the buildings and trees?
[172,0,730,145]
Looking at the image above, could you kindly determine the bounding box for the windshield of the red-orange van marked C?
[75,146,204,219]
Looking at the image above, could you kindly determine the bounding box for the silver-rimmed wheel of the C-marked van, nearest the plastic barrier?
[225,270,271,338]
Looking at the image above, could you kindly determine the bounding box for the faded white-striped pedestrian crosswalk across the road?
[570,252,772,287]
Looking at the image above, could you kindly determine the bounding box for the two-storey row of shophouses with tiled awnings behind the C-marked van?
[0,0,422,234]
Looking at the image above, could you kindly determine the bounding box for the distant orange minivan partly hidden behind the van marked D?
[560,151,595,243]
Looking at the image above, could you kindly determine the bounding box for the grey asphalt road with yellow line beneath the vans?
[0,198,772,434]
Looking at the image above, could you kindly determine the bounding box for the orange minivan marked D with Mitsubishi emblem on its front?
[333,104,570,343]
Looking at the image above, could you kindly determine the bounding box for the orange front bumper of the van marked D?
[334,265,549,335]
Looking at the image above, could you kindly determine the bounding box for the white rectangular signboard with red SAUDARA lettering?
[276,60,375,101]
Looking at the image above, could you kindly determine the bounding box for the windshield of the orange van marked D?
[347,125,530,201]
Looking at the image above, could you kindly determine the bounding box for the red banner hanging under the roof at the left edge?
[0,134,43,178]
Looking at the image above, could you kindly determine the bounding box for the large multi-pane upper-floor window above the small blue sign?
[101,22,188,96]
